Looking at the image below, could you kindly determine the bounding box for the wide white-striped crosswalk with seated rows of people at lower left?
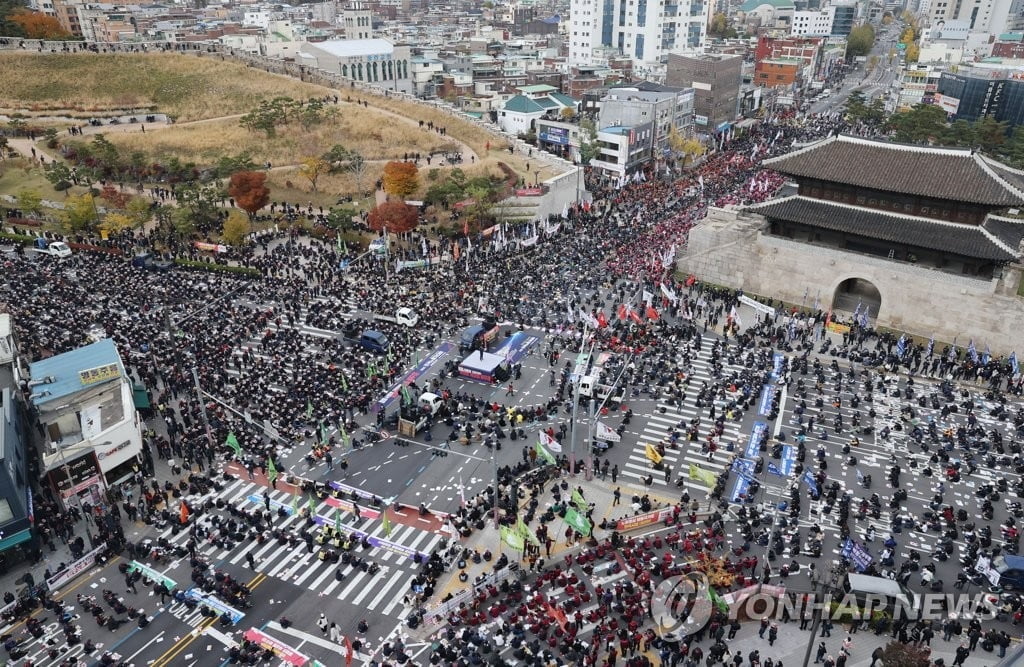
[149,478,444,619]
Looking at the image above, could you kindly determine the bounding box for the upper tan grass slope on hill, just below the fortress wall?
[0,52,334,122]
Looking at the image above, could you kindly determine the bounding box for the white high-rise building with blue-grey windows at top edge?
[568,0,713,70]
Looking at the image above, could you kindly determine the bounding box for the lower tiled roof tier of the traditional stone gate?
[746,195,1024,261]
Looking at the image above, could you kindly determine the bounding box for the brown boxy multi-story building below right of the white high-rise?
[667,53,743,132]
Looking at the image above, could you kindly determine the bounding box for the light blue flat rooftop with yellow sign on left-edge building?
[29,338,125,407]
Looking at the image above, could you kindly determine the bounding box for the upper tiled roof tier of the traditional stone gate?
[763,134,1024,207]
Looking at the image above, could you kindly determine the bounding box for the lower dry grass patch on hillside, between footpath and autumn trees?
[106,109,452,165]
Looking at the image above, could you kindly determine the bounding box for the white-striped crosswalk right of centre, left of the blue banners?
[622,352,741,490]
